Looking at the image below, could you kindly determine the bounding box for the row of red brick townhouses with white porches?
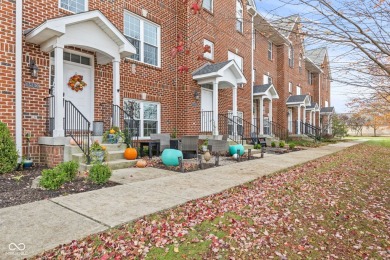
[0,0,333,165]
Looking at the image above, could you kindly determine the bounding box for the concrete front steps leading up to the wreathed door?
[65,144,137,171]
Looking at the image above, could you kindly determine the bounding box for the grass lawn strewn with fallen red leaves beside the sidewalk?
[37,140,390,259]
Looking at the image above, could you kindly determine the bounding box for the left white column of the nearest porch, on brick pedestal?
[53,45,65,137]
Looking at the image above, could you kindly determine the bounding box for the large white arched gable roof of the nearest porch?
[26,10,136,64]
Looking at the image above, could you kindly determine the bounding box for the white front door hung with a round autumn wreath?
[64,61,94,127]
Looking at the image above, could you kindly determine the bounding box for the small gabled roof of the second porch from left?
[192,60,247,87]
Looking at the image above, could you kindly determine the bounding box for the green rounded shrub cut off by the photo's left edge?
[0,122,18,174]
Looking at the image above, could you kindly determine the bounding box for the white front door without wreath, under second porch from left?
[200,88,213,132]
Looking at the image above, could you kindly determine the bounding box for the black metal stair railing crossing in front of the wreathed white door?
[64,100,91,164]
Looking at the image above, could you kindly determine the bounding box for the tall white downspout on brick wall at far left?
[15,0,23,163]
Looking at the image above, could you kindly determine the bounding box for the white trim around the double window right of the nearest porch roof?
[123,10,161,68]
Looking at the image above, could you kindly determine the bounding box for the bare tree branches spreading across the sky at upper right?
[270,0,390,101]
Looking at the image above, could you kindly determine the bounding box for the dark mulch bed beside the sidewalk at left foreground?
[0,167,118,208]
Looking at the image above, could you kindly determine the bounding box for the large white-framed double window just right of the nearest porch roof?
[124,13,161,67]
